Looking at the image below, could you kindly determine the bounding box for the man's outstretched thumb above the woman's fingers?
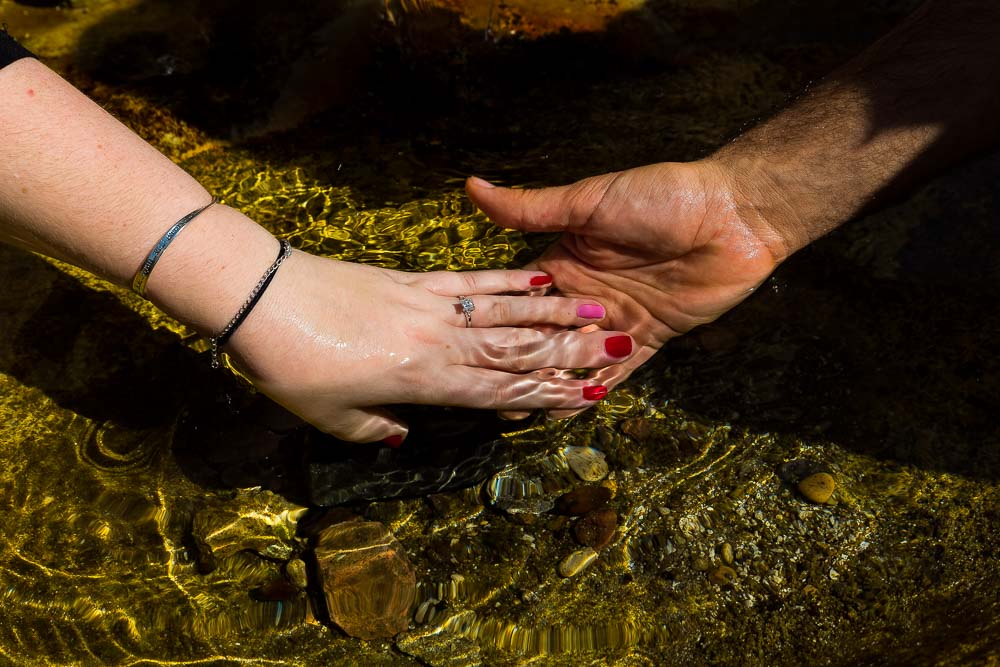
[465,176,607,232]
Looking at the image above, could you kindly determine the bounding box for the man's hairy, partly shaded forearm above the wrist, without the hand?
[709,0,1000,257]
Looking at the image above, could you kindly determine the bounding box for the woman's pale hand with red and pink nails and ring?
[227,252,632,443]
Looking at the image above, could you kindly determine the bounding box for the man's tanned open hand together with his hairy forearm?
[466,0,1000,417]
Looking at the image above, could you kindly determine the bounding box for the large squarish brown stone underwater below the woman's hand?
[315,521,417,639]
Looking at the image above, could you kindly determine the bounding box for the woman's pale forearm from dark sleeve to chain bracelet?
[0,58,278,333]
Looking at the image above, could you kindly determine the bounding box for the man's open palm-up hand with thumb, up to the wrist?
[466,161,785,417]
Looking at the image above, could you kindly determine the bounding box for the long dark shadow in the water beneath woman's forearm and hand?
[0,246,513,505]
